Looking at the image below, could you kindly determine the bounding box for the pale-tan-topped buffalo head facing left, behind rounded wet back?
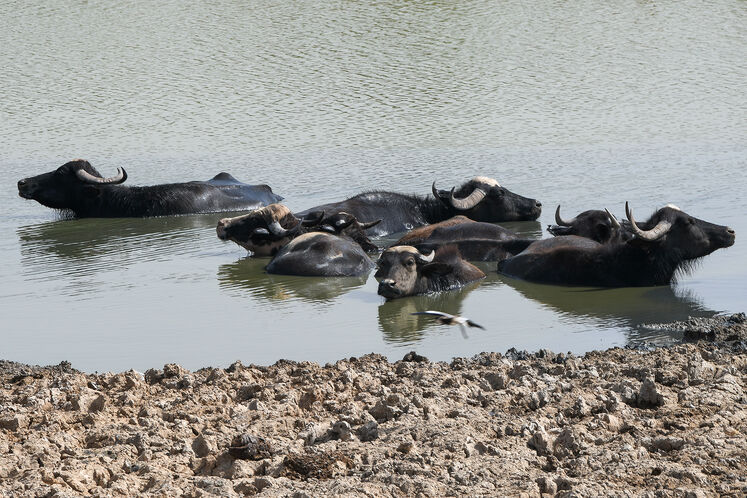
[216,204,318,256]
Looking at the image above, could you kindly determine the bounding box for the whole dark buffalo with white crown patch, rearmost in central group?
[297,176,542,236]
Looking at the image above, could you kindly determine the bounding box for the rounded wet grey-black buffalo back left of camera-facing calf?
[266,232,374,277]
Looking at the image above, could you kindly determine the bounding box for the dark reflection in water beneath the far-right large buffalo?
[500,276,716,343]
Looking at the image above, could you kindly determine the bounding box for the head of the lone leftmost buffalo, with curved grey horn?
[18,159,127,211]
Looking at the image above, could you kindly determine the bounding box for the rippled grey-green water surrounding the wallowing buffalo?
[0,1,747,371]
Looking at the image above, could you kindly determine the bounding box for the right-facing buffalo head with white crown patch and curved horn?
[431,176,542,223]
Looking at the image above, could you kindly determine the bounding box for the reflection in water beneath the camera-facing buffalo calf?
[379,281,481,343]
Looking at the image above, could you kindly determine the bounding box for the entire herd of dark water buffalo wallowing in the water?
[18,159,735,299]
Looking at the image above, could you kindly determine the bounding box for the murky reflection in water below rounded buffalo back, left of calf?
[218,257,368,303]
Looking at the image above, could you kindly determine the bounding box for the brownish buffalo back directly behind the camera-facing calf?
[392,215,535,261]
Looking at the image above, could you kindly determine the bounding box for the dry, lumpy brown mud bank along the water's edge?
[0,315,747,498]
